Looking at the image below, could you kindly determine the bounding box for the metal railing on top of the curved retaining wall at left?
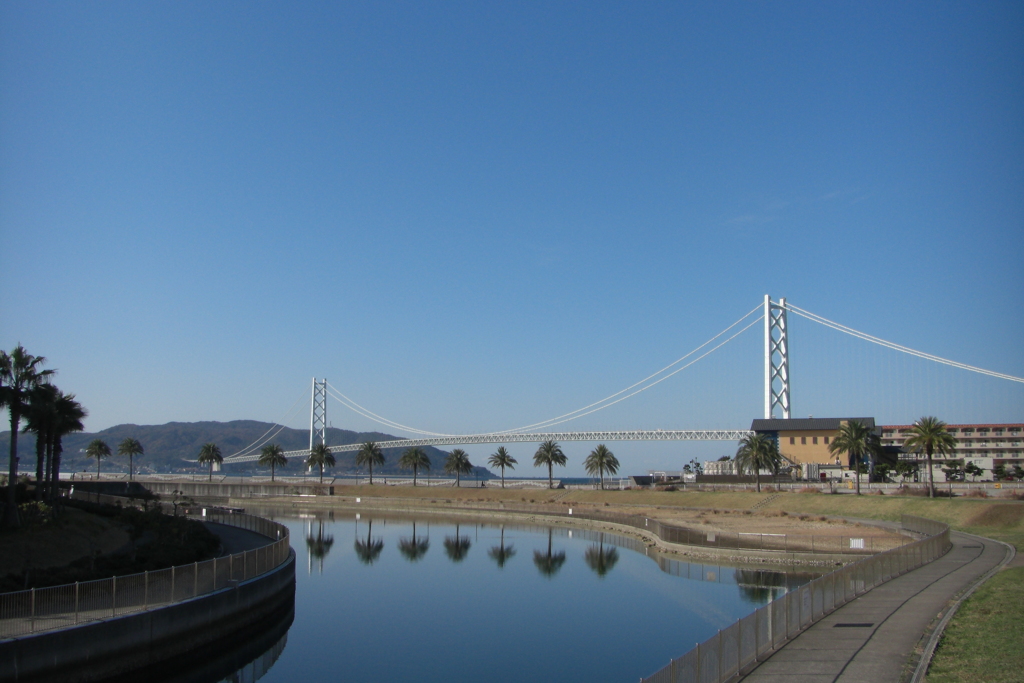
[0,511,291,638]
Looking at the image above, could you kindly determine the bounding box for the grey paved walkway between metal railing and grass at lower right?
[739,531,1007,683]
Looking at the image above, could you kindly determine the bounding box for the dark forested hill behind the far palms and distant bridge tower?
[0,420,493,478]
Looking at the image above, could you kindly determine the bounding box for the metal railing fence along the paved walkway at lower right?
[641,515,949,683]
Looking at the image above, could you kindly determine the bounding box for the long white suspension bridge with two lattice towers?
[224,295,1024,464]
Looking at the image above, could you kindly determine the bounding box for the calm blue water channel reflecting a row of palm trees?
[167,510,816,683]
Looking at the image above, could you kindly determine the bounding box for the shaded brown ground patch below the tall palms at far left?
[0,508,130,577]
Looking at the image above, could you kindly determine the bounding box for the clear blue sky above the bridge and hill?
[0,2,1024,470]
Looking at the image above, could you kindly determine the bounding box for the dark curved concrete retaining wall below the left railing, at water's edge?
[0,551,295,683]
